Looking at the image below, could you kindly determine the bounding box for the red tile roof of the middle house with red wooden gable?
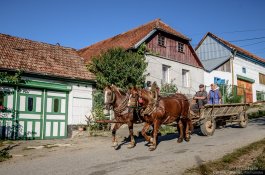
[78,19,189,62]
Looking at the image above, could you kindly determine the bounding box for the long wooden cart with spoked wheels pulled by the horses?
[191,103,249,136]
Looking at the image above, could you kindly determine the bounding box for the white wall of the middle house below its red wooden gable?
[146,55,204,94]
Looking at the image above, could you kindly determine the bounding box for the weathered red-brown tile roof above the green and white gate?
[0,34,95,80]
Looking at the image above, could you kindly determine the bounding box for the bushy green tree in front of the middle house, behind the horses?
[88,46,147,89]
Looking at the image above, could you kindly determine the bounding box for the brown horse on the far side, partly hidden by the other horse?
[104,85,140,149]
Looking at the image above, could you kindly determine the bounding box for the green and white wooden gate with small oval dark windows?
[0,83,68,139]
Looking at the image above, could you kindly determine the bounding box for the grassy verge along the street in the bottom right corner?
[184,139,265,175]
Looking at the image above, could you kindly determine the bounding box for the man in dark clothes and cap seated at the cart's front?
[191,84,207,112]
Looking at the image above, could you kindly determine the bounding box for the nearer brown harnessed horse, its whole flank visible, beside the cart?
[128,88,192,151]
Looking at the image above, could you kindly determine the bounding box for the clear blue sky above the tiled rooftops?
[0,0,265,58]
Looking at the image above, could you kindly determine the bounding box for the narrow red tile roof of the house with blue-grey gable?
[195,32,265,63]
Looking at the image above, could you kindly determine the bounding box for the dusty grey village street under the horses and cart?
[0,117,265,175]
